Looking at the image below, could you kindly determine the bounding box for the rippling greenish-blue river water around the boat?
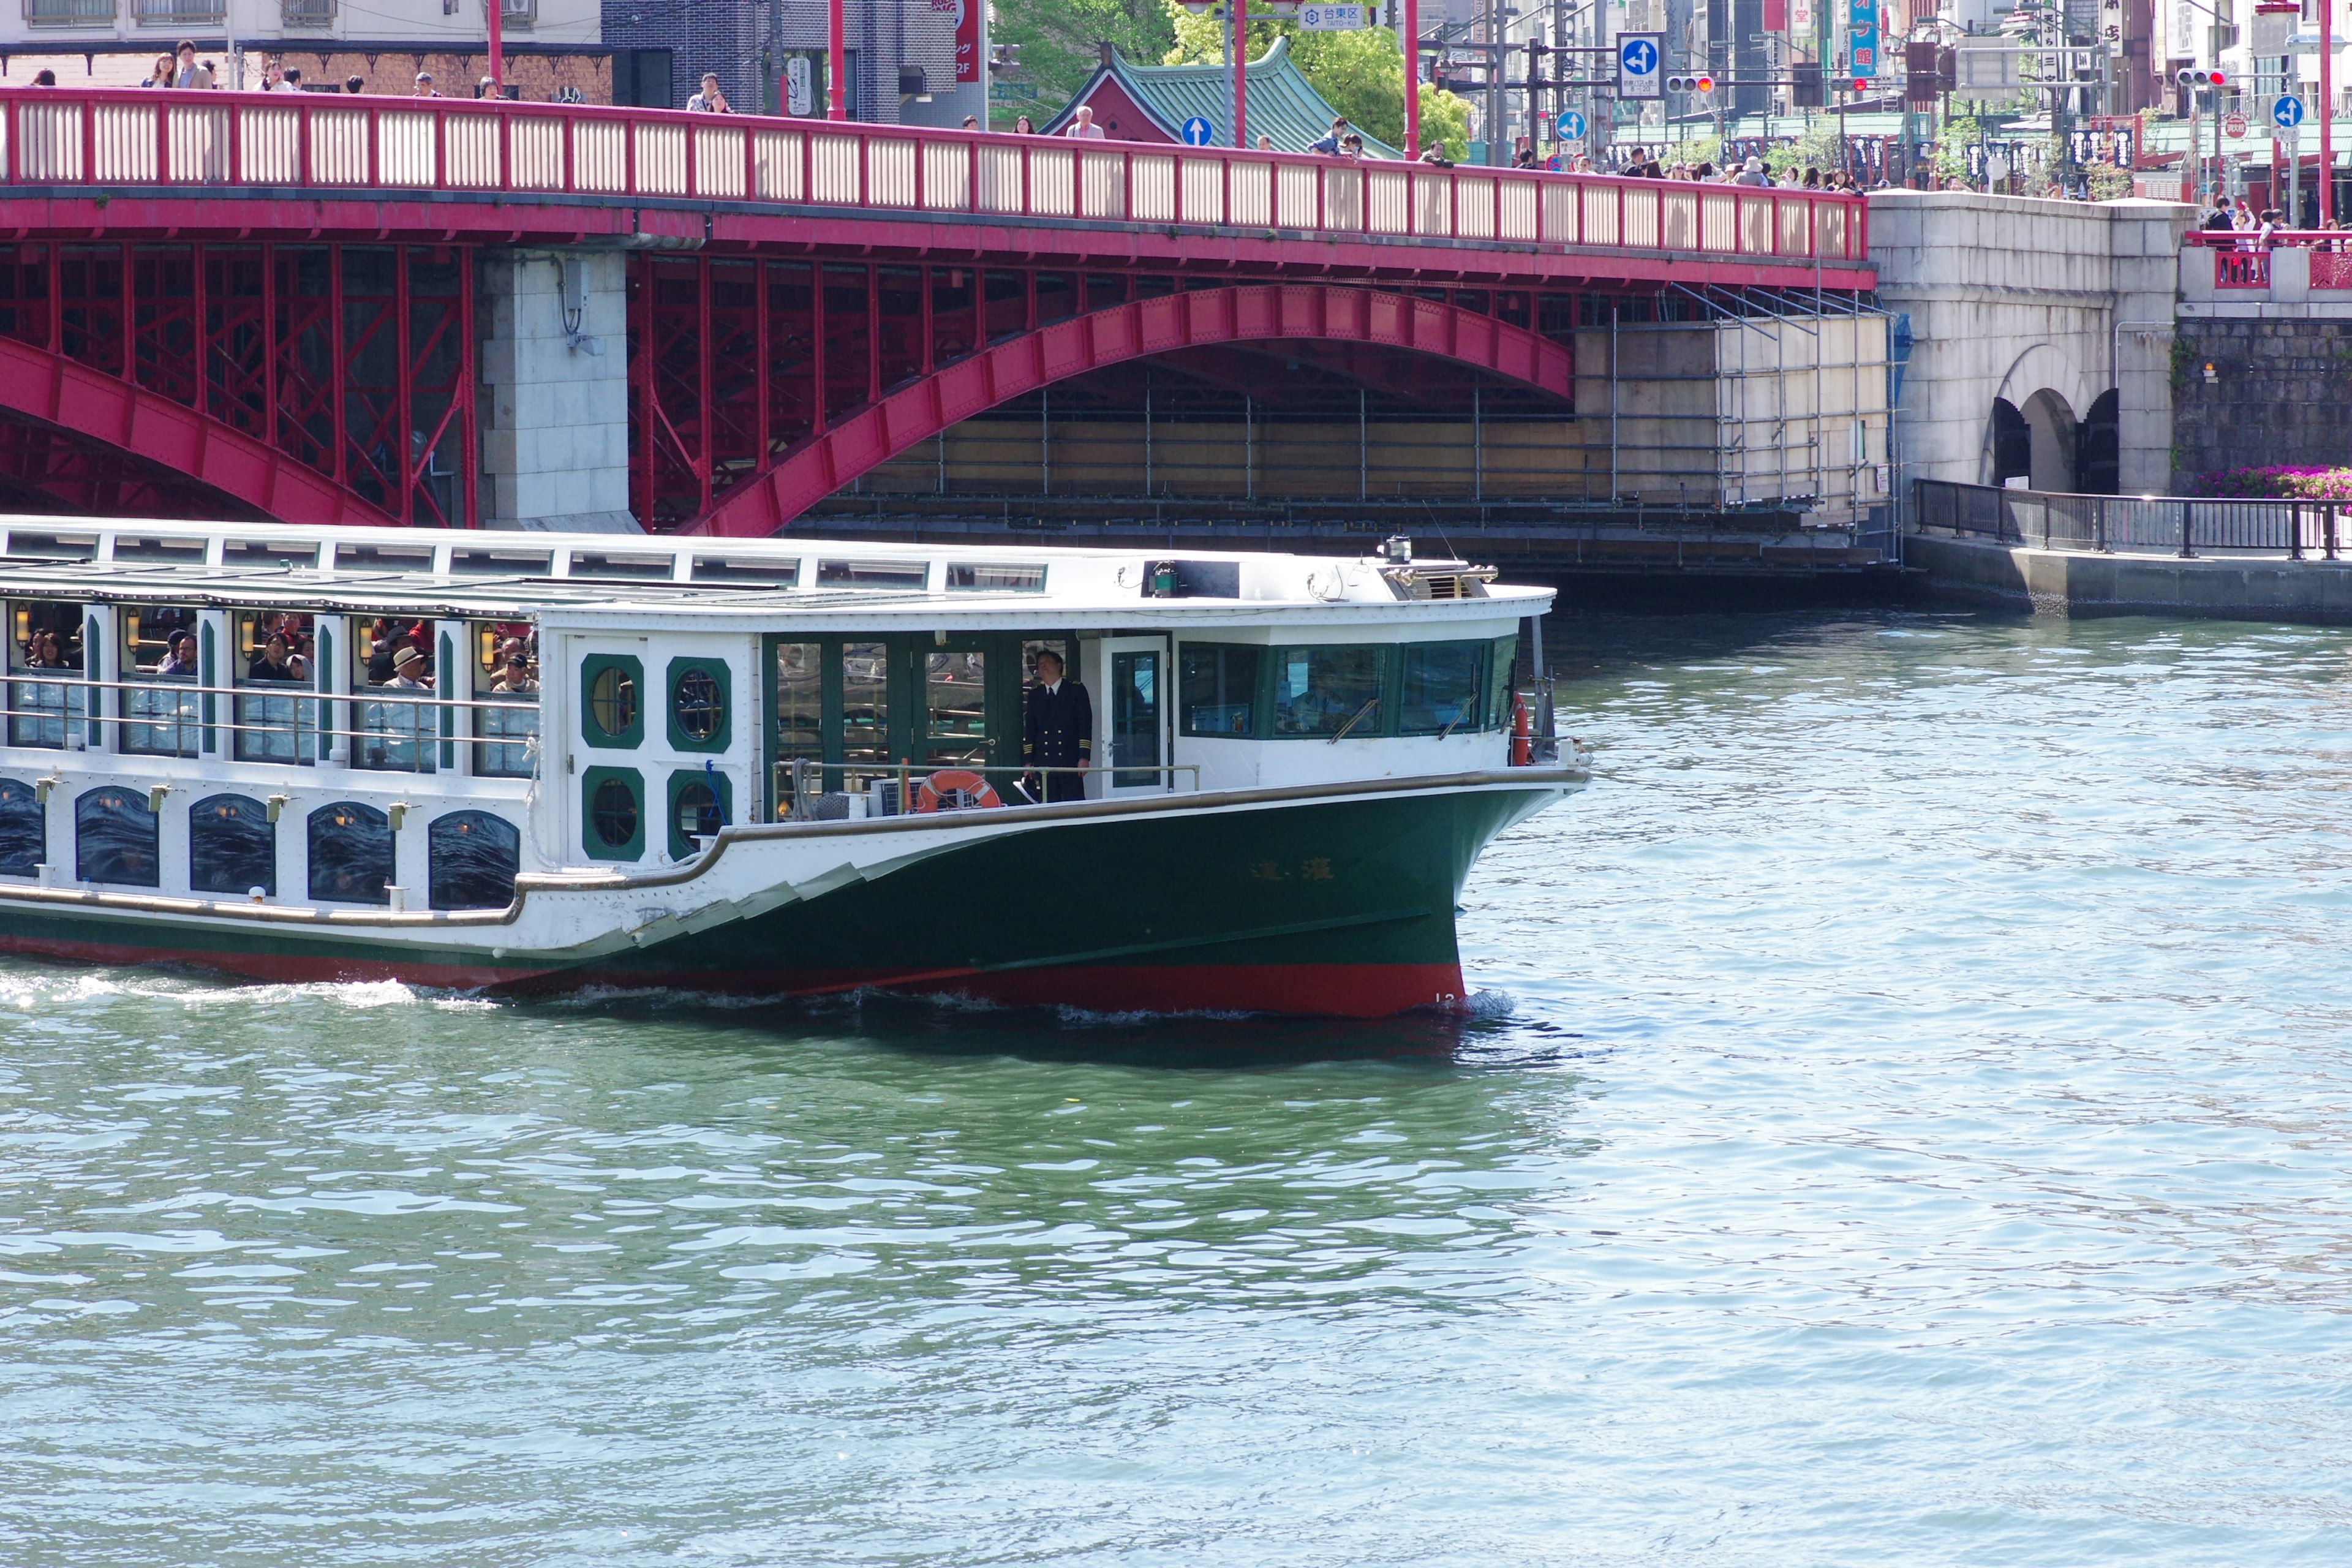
[0,614,2352,1568]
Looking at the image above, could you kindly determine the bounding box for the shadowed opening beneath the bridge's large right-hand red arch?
[812,339,1580,517]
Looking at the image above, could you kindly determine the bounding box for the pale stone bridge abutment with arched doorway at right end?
[1870,190,2192,494]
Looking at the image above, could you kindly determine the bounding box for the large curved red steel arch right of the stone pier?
[680,284,1576,538]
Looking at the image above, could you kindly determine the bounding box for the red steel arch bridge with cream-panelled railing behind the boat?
[0,89,1874,533]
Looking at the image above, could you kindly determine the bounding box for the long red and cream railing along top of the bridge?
[0,89,1870,261]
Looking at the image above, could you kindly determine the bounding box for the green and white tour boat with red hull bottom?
[0,517,1585,1016]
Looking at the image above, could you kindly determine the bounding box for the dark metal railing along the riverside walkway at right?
[1915,480,2352,562]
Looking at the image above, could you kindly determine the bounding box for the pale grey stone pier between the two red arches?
[478,247,639,533]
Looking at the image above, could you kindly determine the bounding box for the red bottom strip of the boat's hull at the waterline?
[0,936,1465,1018]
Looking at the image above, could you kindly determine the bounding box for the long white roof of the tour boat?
[0,515,1550,620]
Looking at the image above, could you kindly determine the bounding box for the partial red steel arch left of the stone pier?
[0,339,402,529]
